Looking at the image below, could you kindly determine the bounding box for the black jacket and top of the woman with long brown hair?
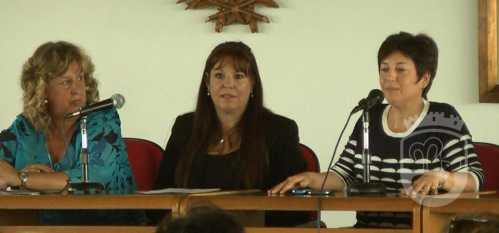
[155,112,309,226]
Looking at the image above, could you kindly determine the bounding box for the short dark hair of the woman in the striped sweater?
[378,32,438,99]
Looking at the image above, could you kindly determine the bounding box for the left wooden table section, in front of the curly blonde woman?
[0,195,183,233]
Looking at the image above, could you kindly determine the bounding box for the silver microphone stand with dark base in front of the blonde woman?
[68,116,104,194]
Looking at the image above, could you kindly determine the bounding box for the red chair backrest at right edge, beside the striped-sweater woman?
[473,142,499,190]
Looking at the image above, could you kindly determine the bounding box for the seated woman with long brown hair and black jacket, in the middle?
[157,42,306,225]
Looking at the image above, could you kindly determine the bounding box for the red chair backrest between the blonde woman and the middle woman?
[123,138,163,191]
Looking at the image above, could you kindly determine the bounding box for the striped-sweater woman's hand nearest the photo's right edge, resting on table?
[404,171,449,196]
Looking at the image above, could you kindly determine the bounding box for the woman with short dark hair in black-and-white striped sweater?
[269,32,484,227]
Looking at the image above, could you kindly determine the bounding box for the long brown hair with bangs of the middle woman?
[175,42,269,188]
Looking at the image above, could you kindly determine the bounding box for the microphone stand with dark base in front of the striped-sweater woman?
[347,108,386,196]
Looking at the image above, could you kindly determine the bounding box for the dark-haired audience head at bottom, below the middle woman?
[156,205,245,233]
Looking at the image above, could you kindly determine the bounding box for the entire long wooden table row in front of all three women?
[0,192,499,233]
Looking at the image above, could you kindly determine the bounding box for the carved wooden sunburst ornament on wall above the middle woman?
[177,0,279,32]
